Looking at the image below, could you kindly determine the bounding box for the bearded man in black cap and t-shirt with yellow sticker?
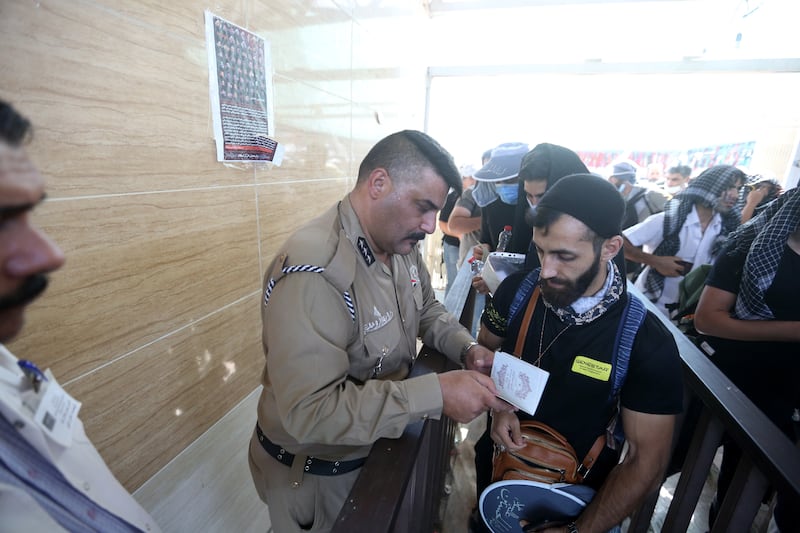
[476,174,683,531]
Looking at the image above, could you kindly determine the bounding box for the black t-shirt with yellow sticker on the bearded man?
[482,273,683,484]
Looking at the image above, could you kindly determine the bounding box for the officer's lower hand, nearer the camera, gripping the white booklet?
[439,370,514,424]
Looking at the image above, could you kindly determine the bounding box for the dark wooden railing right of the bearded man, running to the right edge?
[629,294,800,533]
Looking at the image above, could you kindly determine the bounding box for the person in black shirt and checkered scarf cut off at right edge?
[694,188,800,532]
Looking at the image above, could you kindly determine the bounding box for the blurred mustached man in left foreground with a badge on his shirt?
[0,101,159,532]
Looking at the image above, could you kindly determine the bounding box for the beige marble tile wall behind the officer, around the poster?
[0,0,425,490]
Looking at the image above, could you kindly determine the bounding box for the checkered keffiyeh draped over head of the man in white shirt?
[644,165,746,301]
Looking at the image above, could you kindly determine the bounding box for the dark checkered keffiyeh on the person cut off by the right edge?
[731,188,800,320]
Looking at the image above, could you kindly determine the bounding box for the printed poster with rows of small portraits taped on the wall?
[205,11,283,165]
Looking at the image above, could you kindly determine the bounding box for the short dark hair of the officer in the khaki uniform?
[358,130,463,194]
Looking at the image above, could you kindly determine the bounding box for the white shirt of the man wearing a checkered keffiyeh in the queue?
[622,207,722,317]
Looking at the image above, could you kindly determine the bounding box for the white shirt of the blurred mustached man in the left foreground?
[0,344,161,532]
